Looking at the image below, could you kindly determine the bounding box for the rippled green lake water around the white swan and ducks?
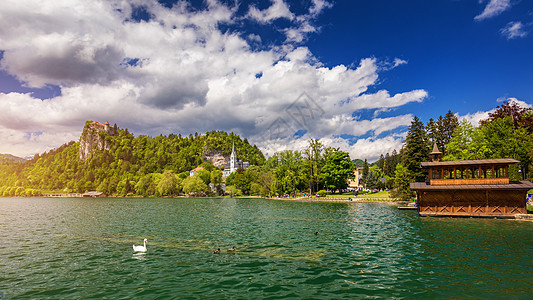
[0,198,533,299]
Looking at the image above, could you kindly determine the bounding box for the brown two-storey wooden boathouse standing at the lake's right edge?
[410,145,533,218]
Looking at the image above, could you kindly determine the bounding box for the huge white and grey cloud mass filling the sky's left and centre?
[0,0,428,158]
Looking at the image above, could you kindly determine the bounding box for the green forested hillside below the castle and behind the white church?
[0,121,265,196]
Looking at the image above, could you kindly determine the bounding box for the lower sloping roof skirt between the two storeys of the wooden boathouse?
[410,181,533,191]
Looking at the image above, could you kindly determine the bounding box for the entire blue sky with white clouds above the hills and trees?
[0,0,533,161]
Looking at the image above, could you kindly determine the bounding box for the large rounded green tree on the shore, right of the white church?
[322,150,354,190]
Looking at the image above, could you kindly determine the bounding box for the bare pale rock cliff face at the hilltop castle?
[79,121,116,160]
